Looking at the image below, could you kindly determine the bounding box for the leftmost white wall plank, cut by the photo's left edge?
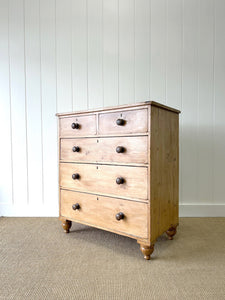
[0,0,12,205]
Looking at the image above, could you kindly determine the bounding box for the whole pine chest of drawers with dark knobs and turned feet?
[57,101,179,259]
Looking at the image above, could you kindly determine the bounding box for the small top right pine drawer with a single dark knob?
[99,108,148,134]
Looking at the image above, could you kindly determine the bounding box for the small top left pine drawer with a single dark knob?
[59,115,96,136]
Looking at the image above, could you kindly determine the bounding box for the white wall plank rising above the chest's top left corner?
[56,0,73,112]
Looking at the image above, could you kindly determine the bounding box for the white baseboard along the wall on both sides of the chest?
[0,204,225,217]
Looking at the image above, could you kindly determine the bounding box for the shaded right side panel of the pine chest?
[150,107,179,242]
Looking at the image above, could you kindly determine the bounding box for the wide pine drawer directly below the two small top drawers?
[60,136,148,164]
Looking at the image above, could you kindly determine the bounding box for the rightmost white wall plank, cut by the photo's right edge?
[213,0,225,204]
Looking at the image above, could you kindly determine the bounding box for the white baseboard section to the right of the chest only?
[179,204,225,217]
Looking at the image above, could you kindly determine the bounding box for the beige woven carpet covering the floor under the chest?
[0,218,225,300]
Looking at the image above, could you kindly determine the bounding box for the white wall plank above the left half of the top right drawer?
[103,0,119,106]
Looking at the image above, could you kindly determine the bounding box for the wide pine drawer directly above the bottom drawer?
[60,163,147,199]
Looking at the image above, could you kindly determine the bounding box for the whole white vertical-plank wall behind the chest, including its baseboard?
[0,0,225,216]
